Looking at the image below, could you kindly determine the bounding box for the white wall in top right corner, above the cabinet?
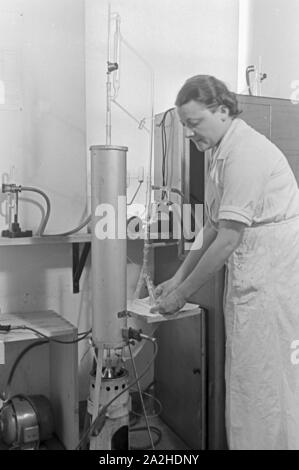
[238,0,299,99]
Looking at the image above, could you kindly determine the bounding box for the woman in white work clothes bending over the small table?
[152,75,299,449]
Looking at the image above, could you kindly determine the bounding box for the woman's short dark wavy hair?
[175,75,241,118]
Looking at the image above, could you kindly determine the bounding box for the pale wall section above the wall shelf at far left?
[0,0,86,233]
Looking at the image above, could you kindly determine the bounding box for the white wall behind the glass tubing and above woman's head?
[86,0,238,202]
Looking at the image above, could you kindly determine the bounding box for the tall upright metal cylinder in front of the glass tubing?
[90,145,128,348]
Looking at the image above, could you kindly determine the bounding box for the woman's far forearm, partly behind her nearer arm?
[175,223,217,282]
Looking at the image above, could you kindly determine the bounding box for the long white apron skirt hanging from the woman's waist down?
[224,217,299,450]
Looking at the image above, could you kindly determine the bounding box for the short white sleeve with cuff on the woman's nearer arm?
[218,144,270,226]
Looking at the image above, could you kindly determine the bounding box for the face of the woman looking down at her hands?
[177,100,232,152]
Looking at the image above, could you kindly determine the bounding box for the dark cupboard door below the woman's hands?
[155,317,205,450]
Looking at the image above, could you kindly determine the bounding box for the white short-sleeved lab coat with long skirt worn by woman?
[206,119,299,450]
